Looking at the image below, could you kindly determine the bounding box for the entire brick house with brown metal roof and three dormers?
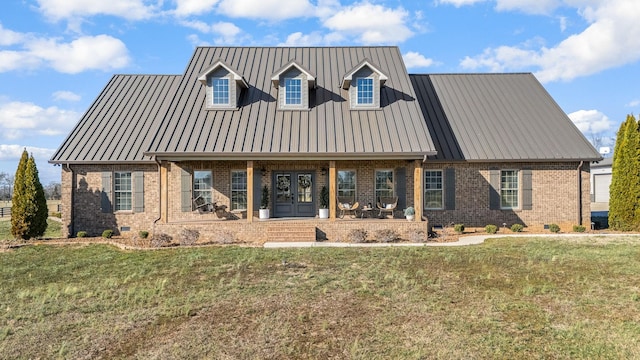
[50,47,600,241]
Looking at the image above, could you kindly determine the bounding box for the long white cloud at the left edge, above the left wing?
[0,31,130,74]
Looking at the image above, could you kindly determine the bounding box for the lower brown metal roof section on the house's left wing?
[50,75,180,163]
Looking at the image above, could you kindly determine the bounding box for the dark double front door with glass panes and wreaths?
[273,171,316,217]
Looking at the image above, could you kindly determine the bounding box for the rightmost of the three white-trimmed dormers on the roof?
[340,59,387,110]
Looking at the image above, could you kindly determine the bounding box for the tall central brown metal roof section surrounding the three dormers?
[147,47,434,159]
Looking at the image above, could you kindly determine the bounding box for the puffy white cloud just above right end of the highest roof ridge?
[324,2,413,44]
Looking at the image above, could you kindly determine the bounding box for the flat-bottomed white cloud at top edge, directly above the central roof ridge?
[217,0,315,20]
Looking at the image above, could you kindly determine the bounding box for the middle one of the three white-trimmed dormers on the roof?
[271,60,316,110]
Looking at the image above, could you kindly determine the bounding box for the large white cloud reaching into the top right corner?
[461,0,640,82]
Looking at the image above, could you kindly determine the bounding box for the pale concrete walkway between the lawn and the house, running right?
[264,233,640,249]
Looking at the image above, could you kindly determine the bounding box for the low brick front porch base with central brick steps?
[153,217,428,245]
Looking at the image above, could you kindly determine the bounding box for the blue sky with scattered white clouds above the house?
[0,0,640,185]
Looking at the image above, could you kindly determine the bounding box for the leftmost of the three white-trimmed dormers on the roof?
[198,60,249,110]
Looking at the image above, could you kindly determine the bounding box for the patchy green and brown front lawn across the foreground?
[0,237,640,359]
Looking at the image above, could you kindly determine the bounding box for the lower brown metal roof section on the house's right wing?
[410,73,601,161]
